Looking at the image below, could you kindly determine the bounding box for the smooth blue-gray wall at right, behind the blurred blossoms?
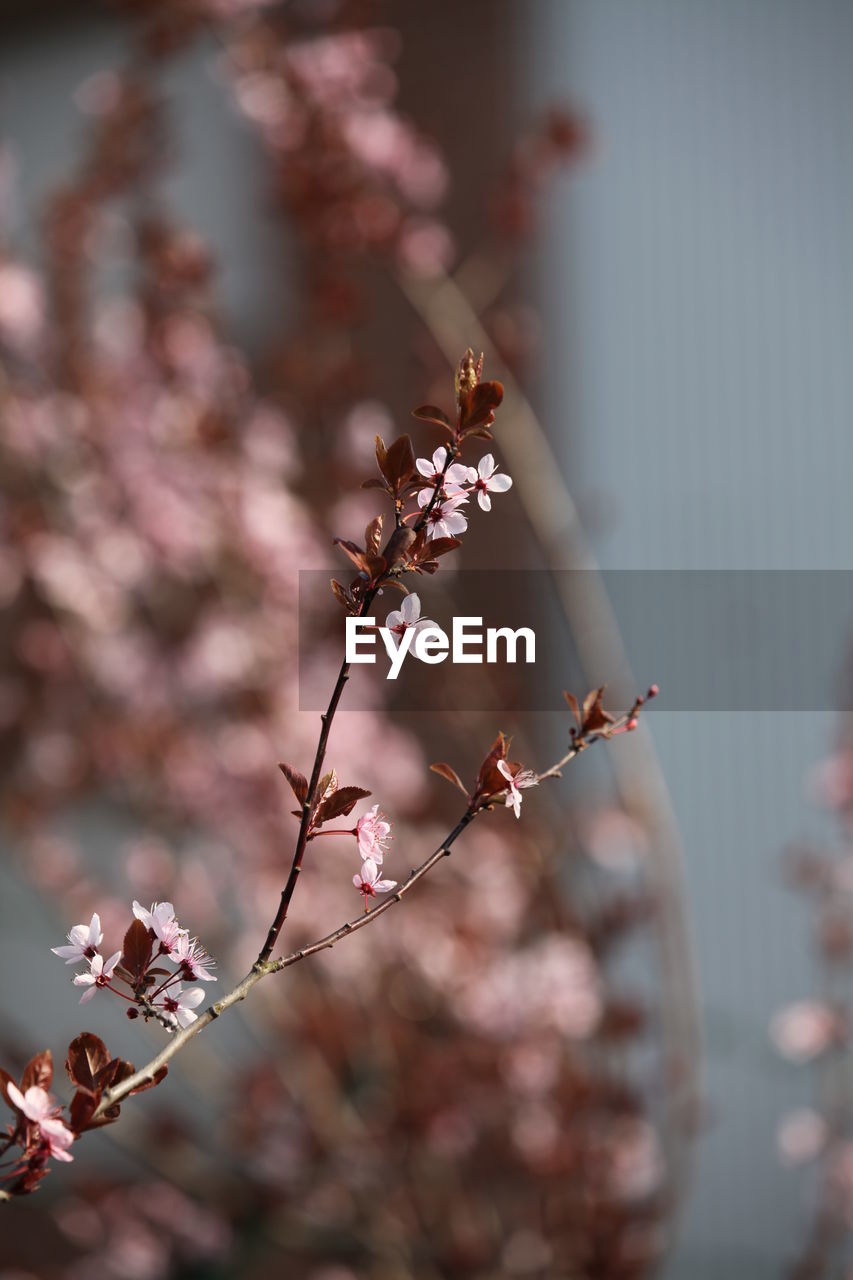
[519,0,853,1280]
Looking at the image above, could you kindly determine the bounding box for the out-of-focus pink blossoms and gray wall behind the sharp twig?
[0,0,853,1280]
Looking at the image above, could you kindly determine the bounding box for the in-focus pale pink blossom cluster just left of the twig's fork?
[51,901,216,1029]
